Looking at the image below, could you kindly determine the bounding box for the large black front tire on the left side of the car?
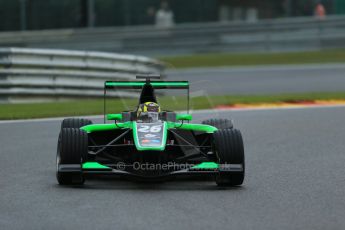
[56,128,88,185]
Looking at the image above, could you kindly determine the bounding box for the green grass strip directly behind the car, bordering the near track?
[0,92,345,120]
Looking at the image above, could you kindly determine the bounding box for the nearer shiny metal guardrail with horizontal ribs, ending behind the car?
[0,48,164,102]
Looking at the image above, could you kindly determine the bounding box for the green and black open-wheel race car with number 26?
[56,76,245,186]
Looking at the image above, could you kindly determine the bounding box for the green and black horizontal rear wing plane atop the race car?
[104,81,189,90]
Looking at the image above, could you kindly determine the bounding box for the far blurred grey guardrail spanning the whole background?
[0,16,345,56]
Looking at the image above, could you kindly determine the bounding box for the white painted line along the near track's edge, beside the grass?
[0,104,345,124]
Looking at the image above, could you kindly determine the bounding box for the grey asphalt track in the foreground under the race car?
[0,107,345,230]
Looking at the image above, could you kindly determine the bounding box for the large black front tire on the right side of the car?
[213,129,245,186]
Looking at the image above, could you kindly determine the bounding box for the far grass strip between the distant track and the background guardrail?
[161,50,345,68]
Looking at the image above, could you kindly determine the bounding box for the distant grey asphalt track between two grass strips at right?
[167,64,345,95]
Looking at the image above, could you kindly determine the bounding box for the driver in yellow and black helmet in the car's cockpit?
[137,102,161,123]
